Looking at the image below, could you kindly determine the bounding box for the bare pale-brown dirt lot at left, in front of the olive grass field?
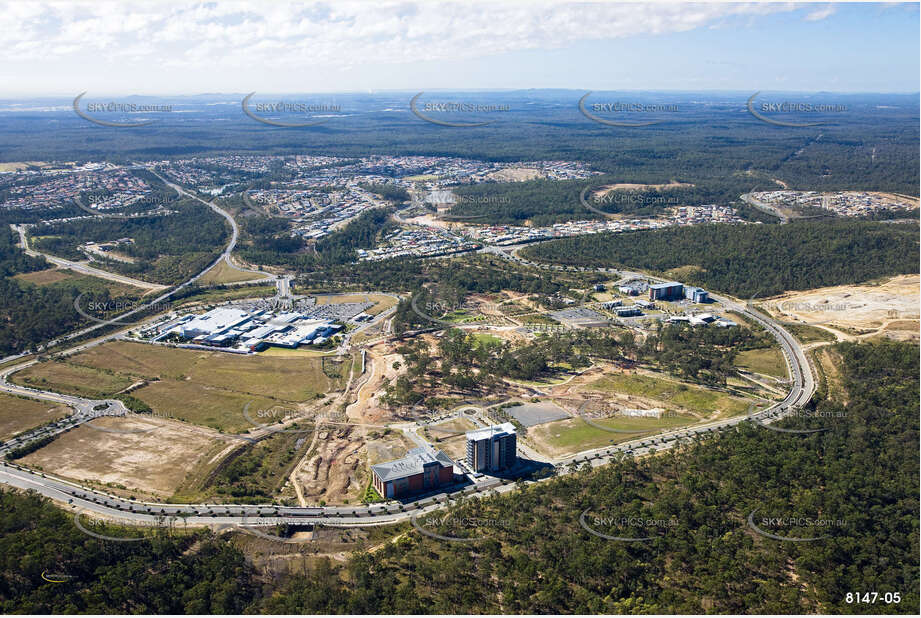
[21,416,228,498]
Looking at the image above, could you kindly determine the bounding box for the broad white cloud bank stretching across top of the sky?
[0,0,792,70]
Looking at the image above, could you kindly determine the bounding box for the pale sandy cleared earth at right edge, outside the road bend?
[764,275,921,340]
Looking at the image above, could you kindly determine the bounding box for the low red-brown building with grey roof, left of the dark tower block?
[371,446,454,498]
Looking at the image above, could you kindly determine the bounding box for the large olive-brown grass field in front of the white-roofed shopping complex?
[13,341,347,432]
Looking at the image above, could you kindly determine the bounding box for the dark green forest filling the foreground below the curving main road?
[0,343,919,614]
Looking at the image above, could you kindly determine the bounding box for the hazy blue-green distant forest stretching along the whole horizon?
[0,89,919,195]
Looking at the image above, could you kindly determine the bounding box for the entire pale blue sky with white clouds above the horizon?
[0,0,921,97]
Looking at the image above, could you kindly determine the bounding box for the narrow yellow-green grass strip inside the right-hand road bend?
[589,373,748,418]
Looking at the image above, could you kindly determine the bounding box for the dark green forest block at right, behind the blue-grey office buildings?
[522,220,919,298]
